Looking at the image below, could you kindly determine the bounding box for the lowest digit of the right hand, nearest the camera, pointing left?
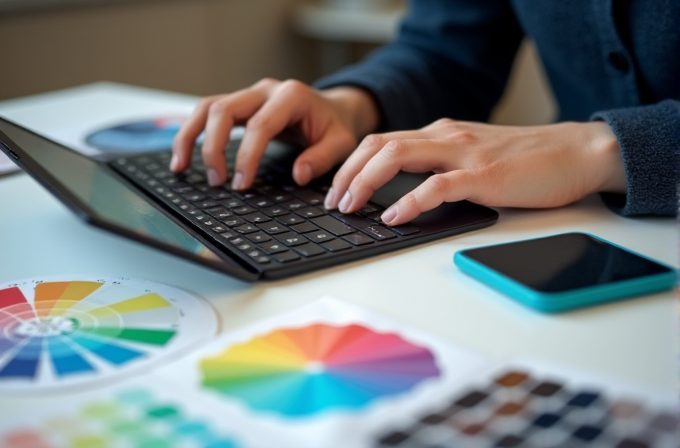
[380,170,478,226]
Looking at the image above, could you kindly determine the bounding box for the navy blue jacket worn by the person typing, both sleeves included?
[315,0,680,216]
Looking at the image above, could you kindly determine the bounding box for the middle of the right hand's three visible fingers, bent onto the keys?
[340,139,455,213]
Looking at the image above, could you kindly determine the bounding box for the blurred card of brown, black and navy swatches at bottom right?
[374,361,680,448]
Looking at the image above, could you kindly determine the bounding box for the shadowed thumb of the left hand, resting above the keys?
[293,126,356,185]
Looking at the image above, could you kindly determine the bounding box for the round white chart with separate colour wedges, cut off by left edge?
[0,277,216,391]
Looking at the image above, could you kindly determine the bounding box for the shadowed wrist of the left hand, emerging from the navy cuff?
[320,86,380,140]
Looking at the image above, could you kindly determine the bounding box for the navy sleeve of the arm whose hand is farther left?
[314,0,523,131]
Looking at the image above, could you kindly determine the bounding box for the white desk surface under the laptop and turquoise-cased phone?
[0,83,678,419]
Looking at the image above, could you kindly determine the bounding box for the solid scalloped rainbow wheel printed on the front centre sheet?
[200,324,441,417]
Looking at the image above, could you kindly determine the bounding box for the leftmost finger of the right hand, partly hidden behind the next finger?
[324,131,418,209]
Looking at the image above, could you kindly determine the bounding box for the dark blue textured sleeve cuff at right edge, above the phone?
[591,100,680,216]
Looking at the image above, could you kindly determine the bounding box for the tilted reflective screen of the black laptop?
[0,119,223,261]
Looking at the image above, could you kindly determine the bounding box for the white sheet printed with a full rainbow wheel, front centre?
[160,298,484,448]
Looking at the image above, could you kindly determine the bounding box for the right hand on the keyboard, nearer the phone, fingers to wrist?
[325,119,626,225]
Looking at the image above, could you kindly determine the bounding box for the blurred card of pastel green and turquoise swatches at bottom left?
[0,379,248,448]
